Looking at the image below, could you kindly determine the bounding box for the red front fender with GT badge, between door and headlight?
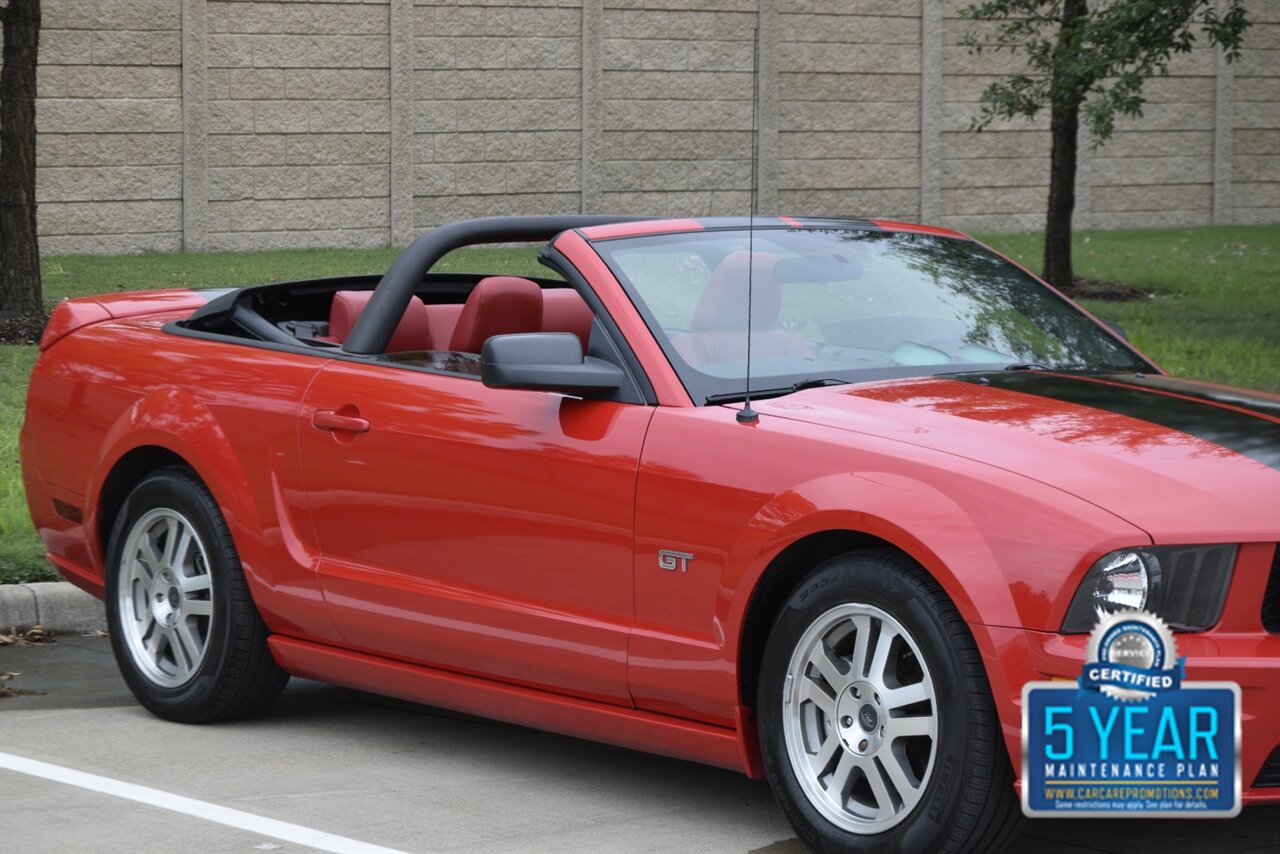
[628,407,1149,725]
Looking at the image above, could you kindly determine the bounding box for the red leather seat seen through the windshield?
[671,252,815,365]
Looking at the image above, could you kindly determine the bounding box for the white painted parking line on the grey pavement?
[0,752,404,854]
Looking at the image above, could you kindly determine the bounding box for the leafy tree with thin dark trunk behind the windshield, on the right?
[960,0,1249,291]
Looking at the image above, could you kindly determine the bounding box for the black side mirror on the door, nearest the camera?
[480,332,626,394]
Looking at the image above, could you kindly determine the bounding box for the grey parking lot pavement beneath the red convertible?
[0,635,1280,854]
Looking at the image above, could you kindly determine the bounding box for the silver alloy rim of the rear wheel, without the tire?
[115,507,214,688]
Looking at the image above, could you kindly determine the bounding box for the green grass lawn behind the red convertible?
[0,225,1280,583]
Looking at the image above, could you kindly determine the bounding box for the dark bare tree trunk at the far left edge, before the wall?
[0,0,45,315]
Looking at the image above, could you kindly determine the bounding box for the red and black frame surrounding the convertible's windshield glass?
[590,224,1162,406]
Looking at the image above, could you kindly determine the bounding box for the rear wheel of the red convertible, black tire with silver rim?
[106,466,289,723]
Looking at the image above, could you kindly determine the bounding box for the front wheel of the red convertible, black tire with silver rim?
[756,549,1021,854]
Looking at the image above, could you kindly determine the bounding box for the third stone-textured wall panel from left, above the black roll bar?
[412,0,582,230]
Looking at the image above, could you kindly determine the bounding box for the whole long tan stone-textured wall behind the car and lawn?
[30,0,1280,254]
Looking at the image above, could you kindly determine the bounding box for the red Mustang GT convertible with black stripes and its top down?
[22,216,1280,851]
